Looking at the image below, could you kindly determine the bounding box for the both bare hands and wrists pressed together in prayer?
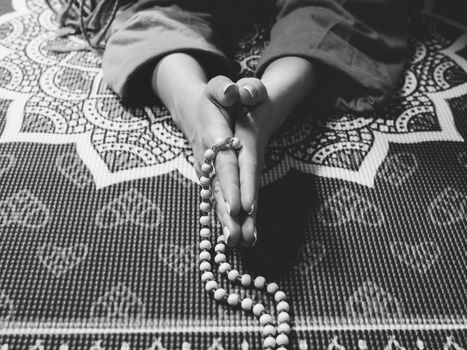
[152,53,316,246]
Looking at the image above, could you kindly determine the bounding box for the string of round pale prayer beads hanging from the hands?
[199,137,291,350]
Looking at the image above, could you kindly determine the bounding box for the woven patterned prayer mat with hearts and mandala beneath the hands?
[0,0,467,350]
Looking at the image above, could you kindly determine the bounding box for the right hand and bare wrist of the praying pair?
[234,56,316,244]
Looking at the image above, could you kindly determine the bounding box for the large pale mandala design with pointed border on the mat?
[0,0,467,188]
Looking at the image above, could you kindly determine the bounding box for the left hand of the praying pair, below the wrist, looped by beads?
[175,76,245,241]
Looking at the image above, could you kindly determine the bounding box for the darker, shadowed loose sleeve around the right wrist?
[257,0,408,112]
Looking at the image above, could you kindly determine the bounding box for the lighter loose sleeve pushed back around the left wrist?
[102,0,232,103]
